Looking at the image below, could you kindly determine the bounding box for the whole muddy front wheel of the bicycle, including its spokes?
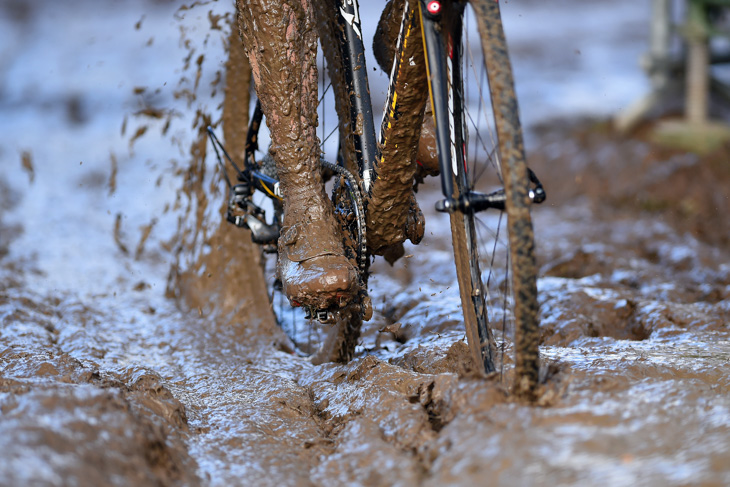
[429,0,539,399]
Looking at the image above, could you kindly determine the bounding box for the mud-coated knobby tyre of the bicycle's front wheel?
[451,0,539,399]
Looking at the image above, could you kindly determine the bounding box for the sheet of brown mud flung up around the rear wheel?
[167,23,275,333]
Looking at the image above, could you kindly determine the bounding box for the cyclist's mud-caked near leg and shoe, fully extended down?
[236,0,358,309]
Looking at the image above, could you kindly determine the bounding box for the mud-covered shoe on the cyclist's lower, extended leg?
[277,221,358,310]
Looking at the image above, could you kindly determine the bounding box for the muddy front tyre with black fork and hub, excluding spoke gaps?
[418,0,545,390]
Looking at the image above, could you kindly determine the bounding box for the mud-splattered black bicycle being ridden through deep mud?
[208,0,545,398]
